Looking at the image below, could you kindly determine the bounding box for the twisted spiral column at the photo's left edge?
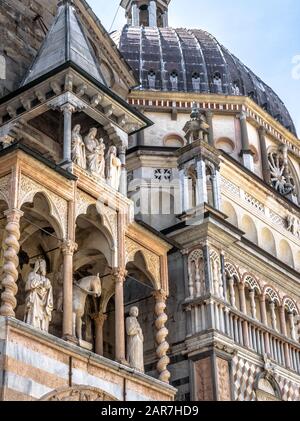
[0,209,23,317]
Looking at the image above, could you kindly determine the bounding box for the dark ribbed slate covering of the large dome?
[112,25,296,135]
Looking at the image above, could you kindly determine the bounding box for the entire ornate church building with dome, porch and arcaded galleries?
[0,0,300,401]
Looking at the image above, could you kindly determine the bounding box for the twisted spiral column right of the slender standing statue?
[154,291,171,383]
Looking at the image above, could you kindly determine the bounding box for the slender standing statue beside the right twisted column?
[126,307,144,373]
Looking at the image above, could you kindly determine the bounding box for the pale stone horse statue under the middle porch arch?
[73,274,102,340]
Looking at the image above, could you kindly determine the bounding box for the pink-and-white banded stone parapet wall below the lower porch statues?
[0,317,176,401]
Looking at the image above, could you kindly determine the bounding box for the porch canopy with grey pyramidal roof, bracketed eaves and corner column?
[0,1,152,161]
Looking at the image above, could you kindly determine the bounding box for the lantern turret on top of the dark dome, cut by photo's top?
[121,0,171,28]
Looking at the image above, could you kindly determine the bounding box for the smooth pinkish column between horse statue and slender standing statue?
[113,268,127,364]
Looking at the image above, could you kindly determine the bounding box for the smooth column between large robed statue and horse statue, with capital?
[61,240,78,339]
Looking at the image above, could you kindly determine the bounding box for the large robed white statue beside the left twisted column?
[24,259,53,332]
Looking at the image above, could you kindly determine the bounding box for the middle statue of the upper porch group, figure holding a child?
[84,127,105,178]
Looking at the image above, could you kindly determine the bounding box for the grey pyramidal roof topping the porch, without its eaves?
[21,2,105,86]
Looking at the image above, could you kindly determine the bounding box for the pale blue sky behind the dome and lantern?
[88,0,300,137]
